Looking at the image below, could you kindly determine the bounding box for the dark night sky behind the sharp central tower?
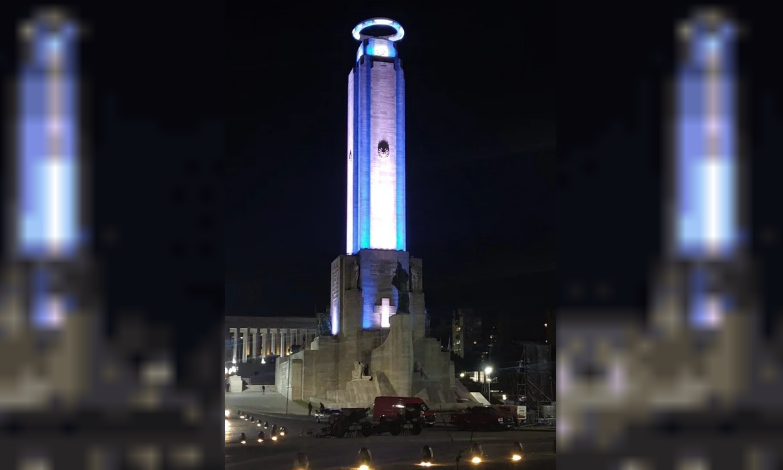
[225,2,556,324]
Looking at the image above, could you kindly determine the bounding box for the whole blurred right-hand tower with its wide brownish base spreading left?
[557,9,781,460]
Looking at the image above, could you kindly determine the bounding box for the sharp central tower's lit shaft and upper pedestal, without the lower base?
[331,18,424,335]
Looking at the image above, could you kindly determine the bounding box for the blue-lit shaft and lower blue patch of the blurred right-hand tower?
[675,12,742,329]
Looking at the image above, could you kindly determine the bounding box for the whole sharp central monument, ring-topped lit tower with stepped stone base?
[286,18,454,406]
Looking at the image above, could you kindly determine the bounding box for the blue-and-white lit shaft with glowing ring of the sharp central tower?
[346,18,406,254]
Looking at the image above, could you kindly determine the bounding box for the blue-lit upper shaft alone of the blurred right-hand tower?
[677,19,740,259]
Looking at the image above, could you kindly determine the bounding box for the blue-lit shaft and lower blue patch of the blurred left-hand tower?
[14,12,84,329]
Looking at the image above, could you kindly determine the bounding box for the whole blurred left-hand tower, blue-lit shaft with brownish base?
[0,10,95,406]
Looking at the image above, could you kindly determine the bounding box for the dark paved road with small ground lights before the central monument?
[225,394,555,470]
